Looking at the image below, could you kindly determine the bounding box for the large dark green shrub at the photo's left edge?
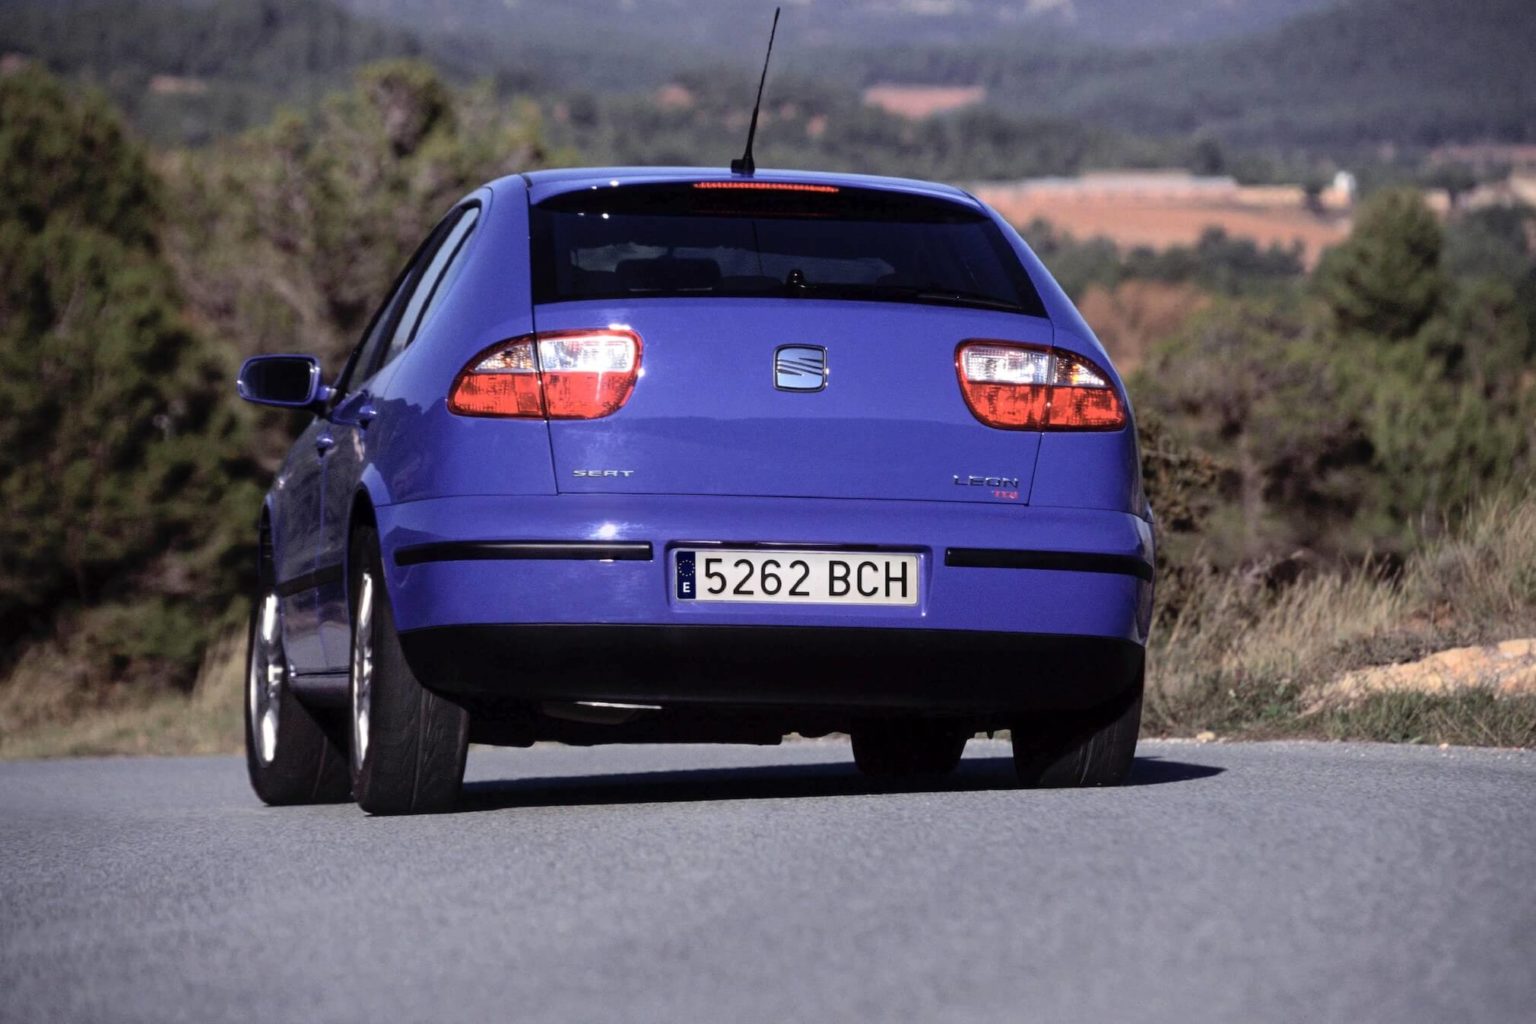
[0,72,253,682]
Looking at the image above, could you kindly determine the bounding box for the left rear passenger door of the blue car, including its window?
[316,204,479,671]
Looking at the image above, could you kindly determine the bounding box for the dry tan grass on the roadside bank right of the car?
[1147,496,1536,746]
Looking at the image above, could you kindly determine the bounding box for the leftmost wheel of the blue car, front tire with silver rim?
[246,565,352,806]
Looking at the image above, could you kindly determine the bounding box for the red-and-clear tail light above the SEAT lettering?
[449,327,641,419]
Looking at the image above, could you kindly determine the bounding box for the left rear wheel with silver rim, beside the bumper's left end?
[349,528,470,814]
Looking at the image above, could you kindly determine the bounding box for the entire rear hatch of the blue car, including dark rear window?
[533,183,1051,504]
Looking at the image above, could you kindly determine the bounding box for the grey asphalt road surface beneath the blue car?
[0,742,1536,1024]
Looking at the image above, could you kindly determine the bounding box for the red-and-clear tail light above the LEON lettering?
[955,341,1126,430]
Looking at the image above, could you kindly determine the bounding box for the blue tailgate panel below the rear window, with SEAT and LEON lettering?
[536,299,1051,502]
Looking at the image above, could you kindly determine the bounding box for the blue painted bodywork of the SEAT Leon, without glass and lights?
[263,169,1154,712]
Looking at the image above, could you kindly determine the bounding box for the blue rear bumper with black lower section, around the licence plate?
[376,494,1154,711]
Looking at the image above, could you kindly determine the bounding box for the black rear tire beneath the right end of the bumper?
[1012,679,1141,789]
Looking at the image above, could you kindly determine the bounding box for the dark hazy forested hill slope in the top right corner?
[823,0,1536,150]
